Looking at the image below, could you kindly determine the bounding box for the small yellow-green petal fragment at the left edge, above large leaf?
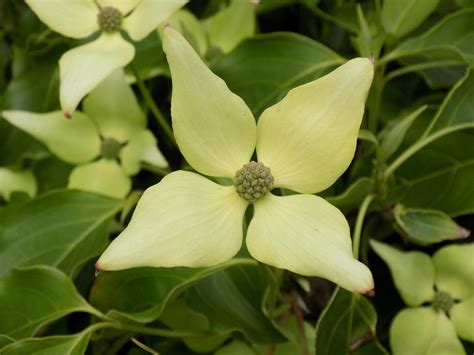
[0,167,37,201]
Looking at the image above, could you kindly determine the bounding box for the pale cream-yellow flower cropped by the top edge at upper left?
[26,0,187,117]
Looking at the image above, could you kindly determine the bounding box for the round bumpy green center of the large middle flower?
[234,161,274,203]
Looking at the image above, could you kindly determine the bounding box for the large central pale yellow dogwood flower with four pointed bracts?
[96,28,373,293]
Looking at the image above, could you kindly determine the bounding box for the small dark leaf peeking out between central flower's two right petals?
[325,177,374,213]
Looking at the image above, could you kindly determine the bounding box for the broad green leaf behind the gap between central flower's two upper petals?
[212,32,344,118]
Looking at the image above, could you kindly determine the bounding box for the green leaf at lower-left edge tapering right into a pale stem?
[0,266,98,340]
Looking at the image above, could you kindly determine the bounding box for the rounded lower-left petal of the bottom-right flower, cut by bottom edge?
[390,308,465,355]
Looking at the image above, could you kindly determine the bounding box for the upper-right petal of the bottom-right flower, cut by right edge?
[433,243,474,300]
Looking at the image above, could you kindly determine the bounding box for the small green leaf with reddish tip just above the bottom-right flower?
[394,204,470,245]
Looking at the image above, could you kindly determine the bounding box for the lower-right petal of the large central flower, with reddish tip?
[247,193,374,293]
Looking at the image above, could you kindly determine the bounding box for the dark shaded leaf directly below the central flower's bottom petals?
[186,265,286,343]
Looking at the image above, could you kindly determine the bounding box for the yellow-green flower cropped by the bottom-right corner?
[371,241,474,355]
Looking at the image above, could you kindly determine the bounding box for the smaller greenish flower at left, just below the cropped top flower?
[2,69,168,198]
